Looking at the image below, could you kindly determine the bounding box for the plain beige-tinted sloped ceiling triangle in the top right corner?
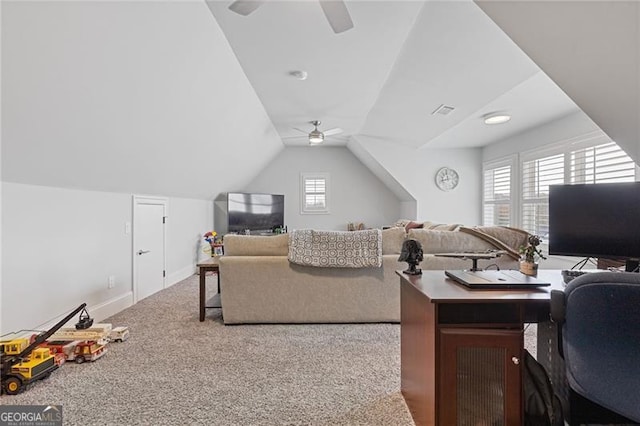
[476,0,640,163]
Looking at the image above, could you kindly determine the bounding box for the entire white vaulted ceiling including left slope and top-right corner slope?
[1,0,640,199]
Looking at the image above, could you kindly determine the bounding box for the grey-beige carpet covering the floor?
[0,276,413,425]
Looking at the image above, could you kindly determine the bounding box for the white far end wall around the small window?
[242,147,401,230]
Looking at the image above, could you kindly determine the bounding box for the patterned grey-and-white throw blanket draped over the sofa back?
[289,229,382,268]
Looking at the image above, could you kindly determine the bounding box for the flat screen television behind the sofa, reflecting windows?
[227,192,284,233]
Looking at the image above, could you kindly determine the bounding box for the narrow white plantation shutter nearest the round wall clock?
[482,165,512,226]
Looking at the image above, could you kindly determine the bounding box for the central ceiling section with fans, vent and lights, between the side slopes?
[207,0,578,148]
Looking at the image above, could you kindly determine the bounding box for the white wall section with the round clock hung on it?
[357,136,482,225]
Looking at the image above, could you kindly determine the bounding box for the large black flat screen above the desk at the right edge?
[549,182,640,270]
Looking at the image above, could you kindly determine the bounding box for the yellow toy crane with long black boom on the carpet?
[0,303,88,395]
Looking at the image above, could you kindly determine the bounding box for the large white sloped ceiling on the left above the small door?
[2,1,283,199]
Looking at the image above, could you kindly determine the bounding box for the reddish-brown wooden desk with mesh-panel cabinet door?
[396,270,564,426]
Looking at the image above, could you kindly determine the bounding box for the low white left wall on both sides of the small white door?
[0,182,213,334]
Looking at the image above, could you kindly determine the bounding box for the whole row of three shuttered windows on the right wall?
[482,132,640,242]
